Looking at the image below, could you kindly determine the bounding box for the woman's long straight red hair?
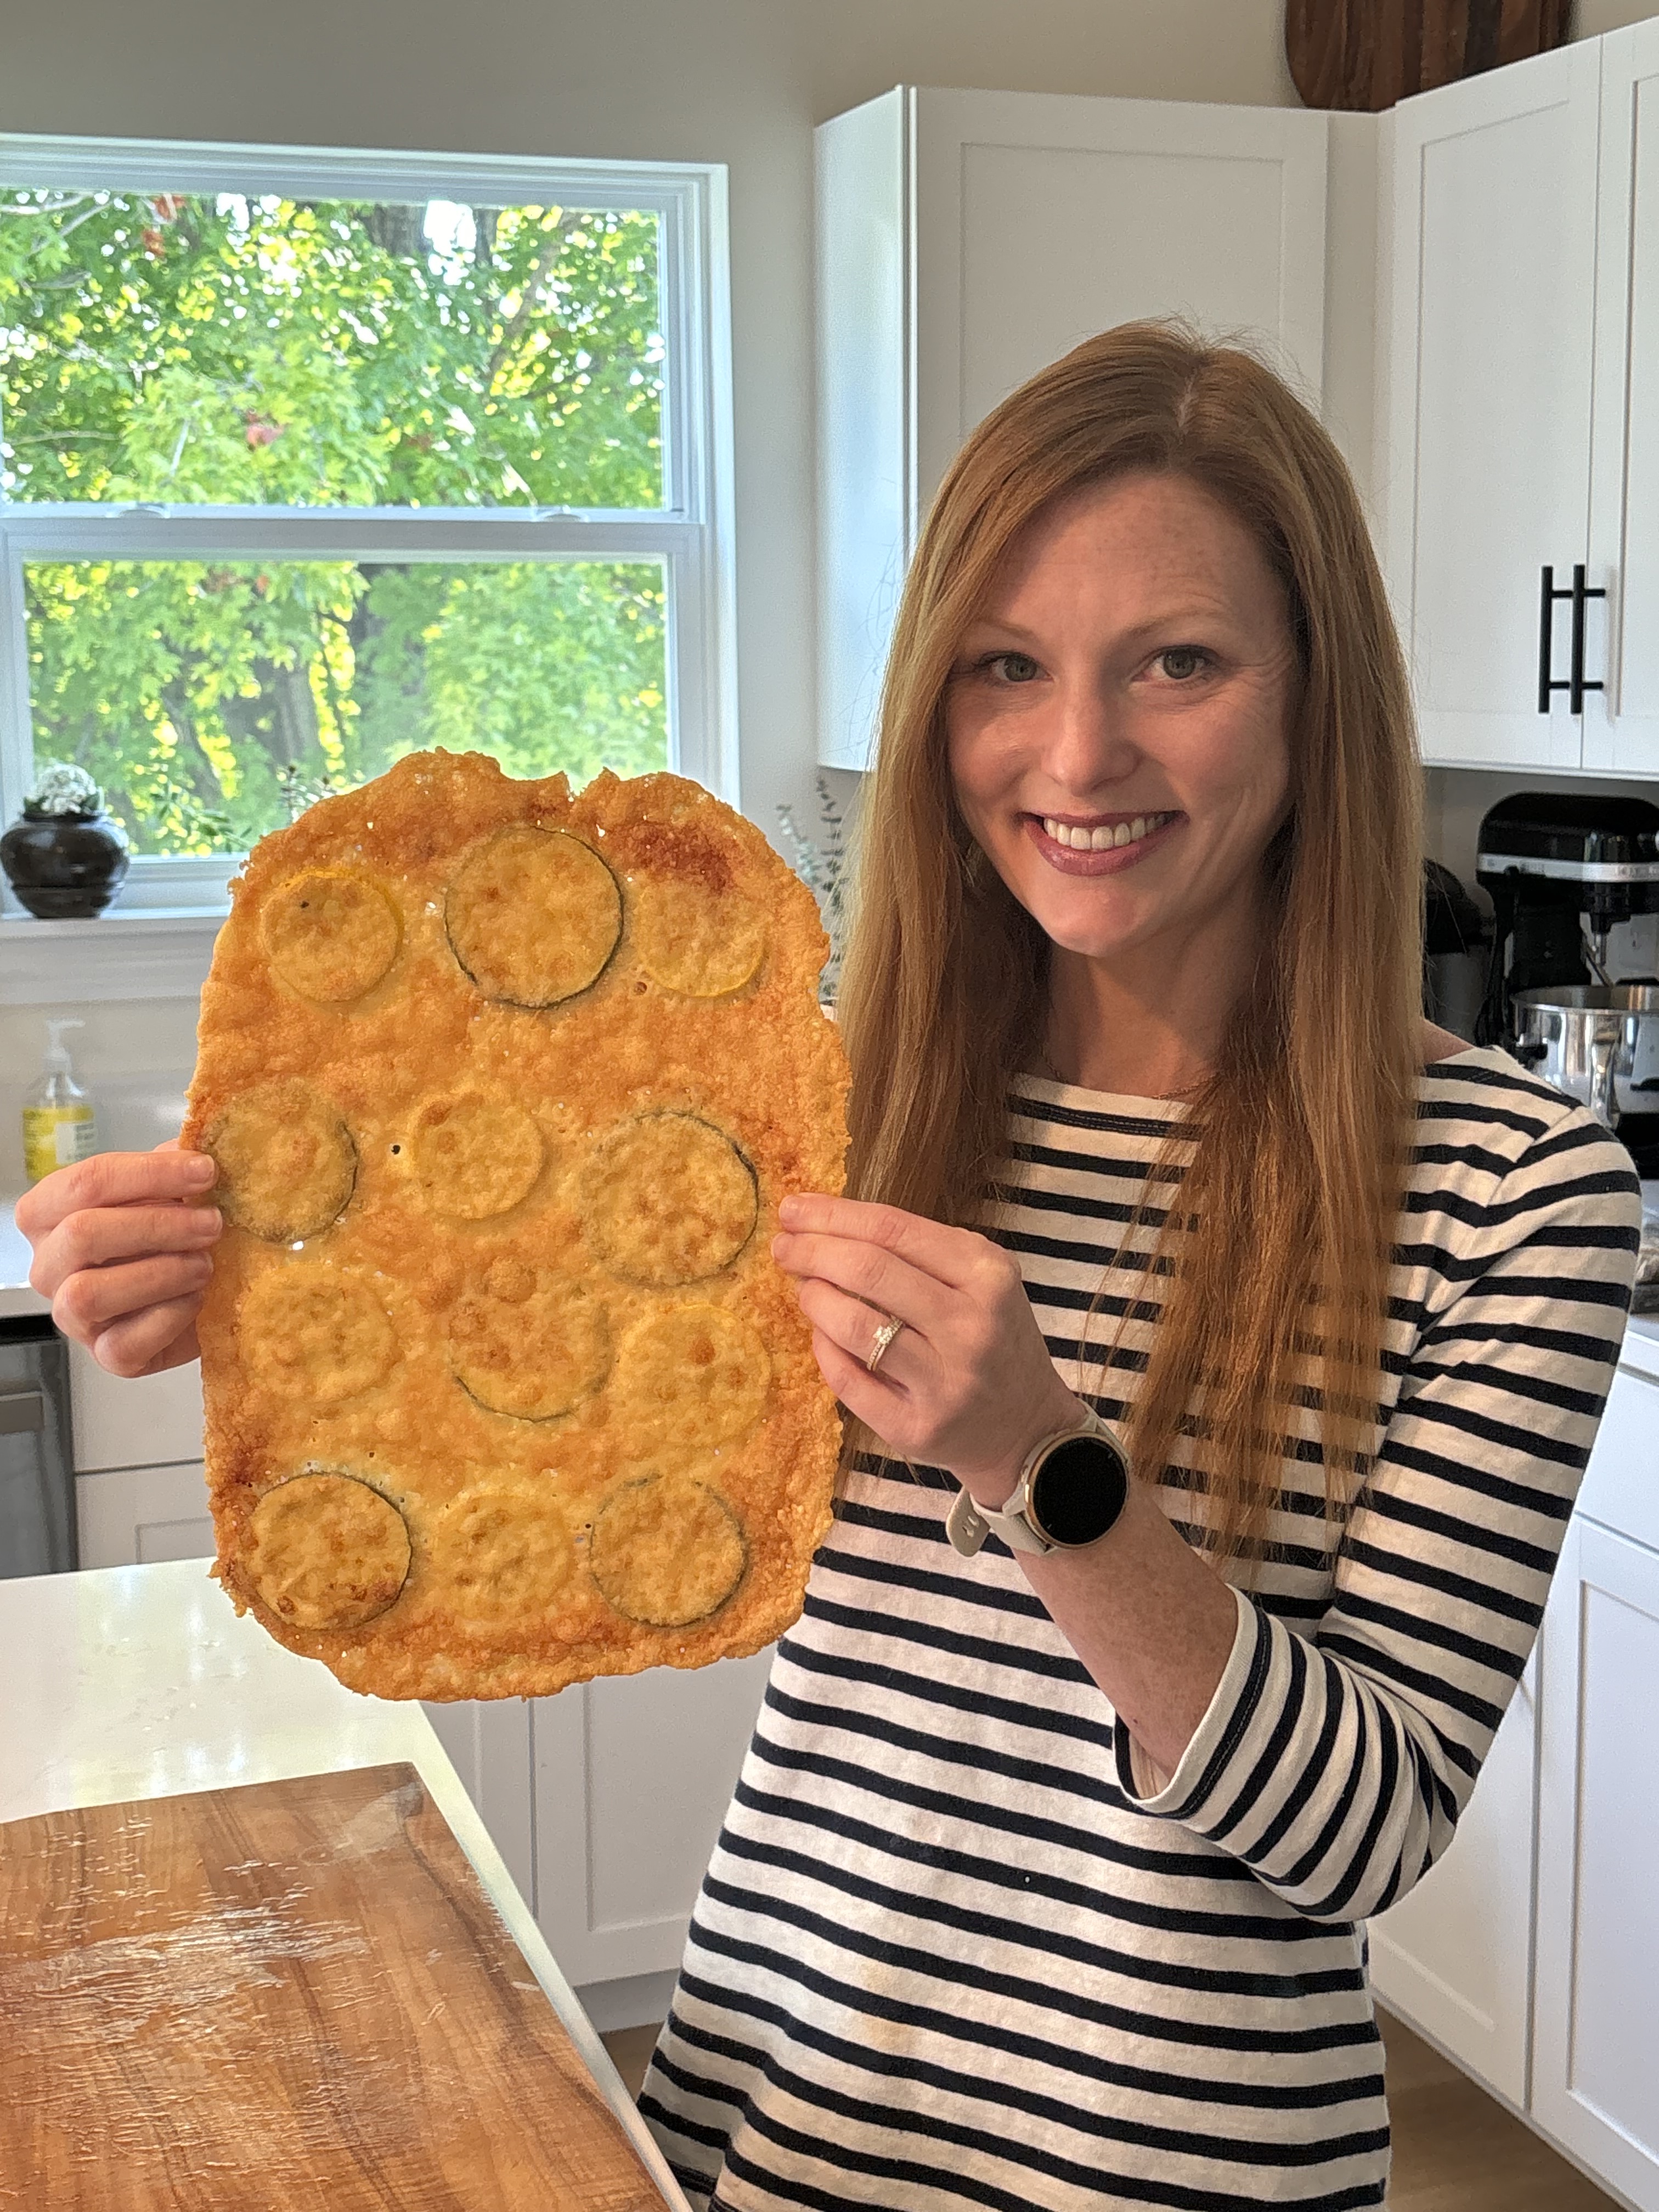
[838,323,1423,1555]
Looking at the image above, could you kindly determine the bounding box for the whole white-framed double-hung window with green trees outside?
[0,137,737,909]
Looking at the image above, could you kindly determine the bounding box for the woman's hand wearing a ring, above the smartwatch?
[772,1197,1082,1506]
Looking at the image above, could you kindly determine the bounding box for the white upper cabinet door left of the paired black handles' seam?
[1378,42,1604,768]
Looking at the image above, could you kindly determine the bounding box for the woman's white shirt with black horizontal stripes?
[641,1048,1641,2212]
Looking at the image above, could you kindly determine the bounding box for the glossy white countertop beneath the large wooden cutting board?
[0,1560,688,2212]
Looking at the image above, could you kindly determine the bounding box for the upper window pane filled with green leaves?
[0,188,664,506]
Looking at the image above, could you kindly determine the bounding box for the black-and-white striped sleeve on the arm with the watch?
[1117,1108,1641,1920]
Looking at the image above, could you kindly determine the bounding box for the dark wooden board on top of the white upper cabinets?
[1285,0,1573,113]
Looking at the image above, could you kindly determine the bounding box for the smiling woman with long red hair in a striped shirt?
[20,328,1639,2212]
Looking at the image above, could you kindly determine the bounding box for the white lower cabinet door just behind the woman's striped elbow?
[1369,1650,1537,2108]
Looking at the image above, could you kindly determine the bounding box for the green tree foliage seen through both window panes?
[0,190,666,851]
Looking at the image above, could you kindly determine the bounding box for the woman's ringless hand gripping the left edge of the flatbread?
[15,1144,223,1376]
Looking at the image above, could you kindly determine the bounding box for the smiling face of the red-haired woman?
[947,473,1296,964]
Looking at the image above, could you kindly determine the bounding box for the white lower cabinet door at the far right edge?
[1533,1513,1659,2212]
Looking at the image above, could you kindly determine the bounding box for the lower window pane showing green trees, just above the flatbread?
[24,560,668,854]
